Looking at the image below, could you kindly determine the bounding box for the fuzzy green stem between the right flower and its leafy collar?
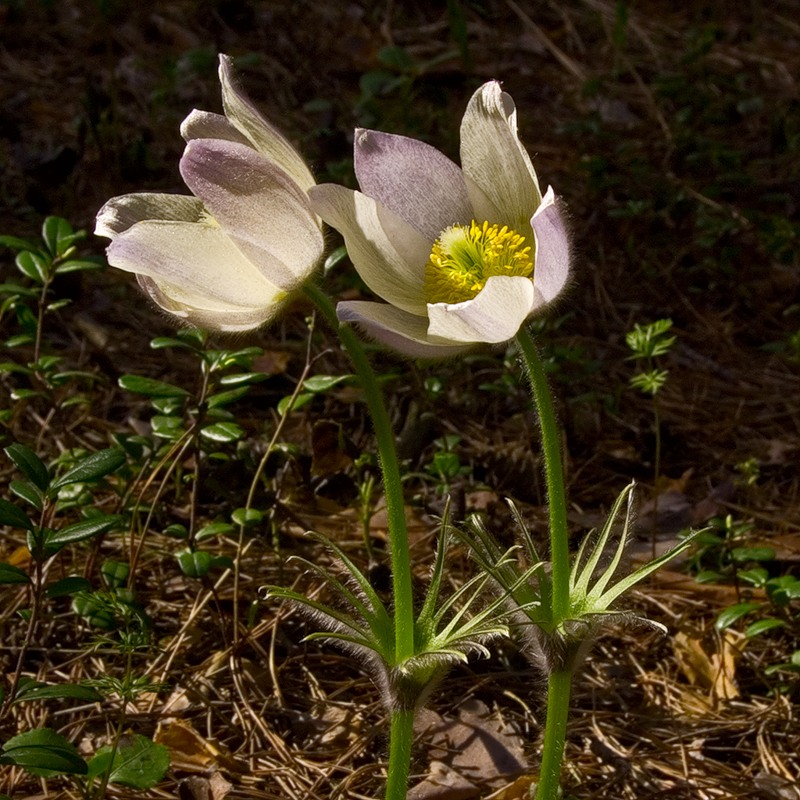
[517,328,570,620]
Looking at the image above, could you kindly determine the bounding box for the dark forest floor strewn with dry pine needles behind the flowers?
[0,0,800,800]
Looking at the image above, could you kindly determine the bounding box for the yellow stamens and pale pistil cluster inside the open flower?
[425,220,533,303]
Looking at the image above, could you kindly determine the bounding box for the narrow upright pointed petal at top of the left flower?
[219,55,314,192]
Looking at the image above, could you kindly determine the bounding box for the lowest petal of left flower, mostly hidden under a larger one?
[136,275,278,333]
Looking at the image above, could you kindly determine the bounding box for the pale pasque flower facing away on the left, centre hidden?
[95,55,324,331]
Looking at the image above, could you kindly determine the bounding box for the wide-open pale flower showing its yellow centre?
[310,81,569,357]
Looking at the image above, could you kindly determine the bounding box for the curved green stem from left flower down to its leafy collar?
[305,281,414,664]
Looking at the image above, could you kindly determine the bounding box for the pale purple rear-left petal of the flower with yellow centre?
[355,128,472,239]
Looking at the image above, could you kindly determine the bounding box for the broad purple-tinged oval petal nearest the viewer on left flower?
[180,139,324,290]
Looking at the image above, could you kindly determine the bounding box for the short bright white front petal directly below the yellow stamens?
[428,275,534,344]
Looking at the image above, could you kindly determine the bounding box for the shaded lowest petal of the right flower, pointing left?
[336,301,469,358]
